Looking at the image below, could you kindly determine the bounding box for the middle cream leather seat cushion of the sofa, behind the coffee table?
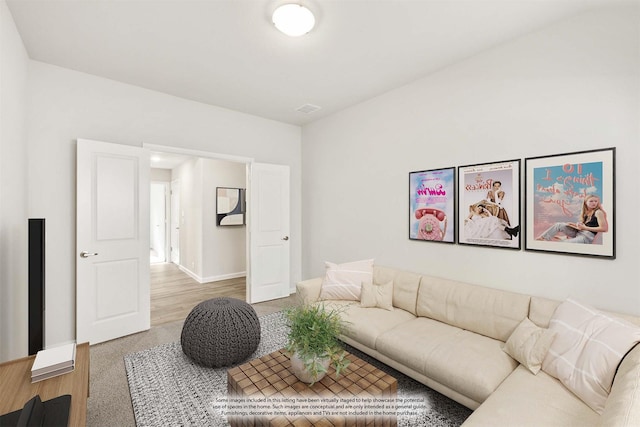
[376,317,518,402]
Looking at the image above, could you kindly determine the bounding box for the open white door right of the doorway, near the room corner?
[247,163,290,303]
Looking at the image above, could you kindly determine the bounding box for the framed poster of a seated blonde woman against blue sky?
[525,148,615,259]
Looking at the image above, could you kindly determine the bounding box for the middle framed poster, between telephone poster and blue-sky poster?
[458,159,520,250]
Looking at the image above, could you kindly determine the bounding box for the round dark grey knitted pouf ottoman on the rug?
[180,297,260,368]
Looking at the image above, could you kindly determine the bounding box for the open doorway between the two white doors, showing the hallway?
[150,150,247,324]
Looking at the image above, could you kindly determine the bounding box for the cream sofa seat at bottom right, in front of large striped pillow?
[462,365,600,427]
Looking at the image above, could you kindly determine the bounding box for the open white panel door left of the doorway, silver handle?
[76,139,150,344]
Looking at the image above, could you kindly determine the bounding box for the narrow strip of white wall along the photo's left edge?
[0,0,28,362]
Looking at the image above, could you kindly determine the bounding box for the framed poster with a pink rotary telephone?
[409,167,456,243]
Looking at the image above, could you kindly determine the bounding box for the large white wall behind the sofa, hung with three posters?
[303,3,640,315]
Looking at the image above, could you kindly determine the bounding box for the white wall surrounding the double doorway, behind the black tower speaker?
[24,61,301,345]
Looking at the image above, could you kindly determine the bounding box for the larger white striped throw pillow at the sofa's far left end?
[320,259,373,301]
